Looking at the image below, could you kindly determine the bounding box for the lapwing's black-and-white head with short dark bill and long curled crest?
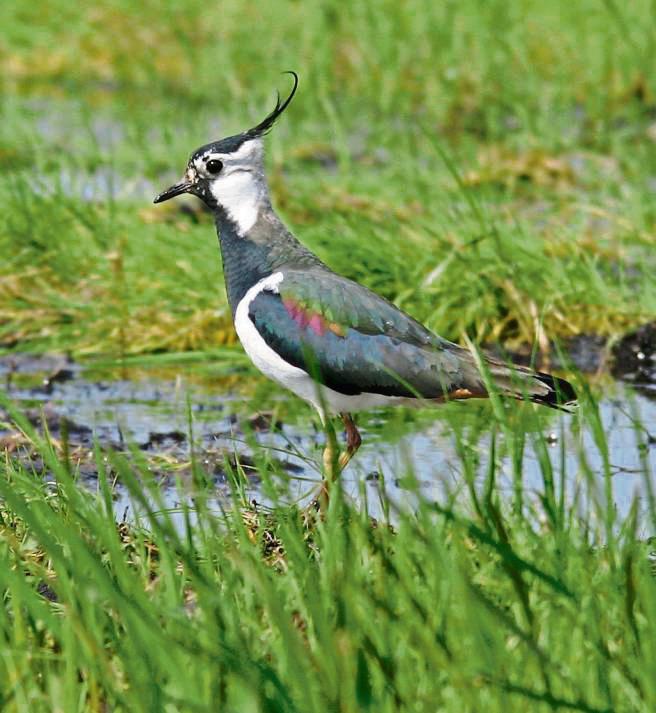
[154,72,298,232]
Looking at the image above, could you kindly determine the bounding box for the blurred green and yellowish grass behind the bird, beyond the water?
[0,0,656,354]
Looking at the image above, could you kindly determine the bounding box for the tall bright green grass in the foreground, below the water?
[0,384,656,713]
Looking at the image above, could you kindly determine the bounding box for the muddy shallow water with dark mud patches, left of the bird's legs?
[0,354,302,487]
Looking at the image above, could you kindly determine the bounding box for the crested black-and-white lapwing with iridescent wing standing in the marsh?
[155,72,576,496]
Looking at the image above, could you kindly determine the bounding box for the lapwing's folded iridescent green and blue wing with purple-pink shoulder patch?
[249,270,478,398]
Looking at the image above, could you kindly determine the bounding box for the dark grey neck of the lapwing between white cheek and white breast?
[215,201,327,318]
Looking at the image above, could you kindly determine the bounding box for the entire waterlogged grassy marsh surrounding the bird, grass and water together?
[0,0,656,713]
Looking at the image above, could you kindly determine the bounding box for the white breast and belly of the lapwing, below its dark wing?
[235,272,416,419]
